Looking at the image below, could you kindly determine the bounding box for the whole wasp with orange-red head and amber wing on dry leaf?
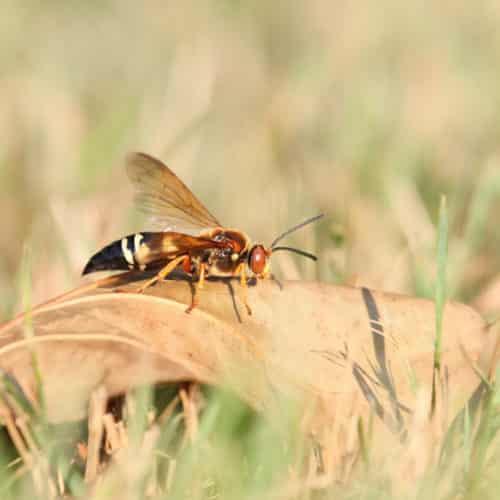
[82,153,323,314]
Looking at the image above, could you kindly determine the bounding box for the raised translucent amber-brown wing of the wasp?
[126,153,220,234]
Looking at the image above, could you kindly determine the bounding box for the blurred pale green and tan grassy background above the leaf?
[0,0,500,319]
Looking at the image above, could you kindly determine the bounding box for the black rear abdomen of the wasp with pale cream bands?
[82,233,156,275]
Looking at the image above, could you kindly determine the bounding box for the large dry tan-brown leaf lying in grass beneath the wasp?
[0,278,498,460]
